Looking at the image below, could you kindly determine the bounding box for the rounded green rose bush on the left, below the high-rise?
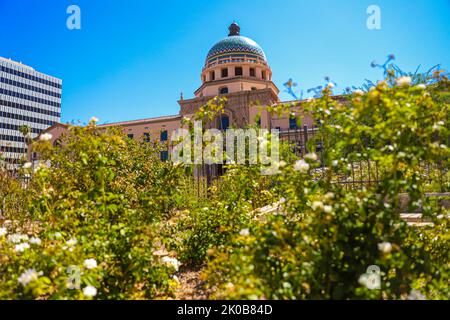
[0,123,183,299]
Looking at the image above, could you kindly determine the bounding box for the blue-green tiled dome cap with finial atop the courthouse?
[206,23,267,61]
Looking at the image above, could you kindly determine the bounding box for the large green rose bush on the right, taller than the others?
[206,79,450,299]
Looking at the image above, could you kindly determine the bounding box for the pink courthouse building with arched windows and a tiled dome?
[34,23,314,159]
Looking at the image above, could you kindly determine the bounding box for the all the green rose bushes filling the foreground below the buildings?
[0,77,450,299]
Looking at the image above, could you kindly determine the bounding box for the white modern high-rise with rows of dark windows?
[0,57,62,169]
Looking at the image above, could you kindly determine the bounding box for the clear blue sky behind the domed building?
[0,0,450,122]
